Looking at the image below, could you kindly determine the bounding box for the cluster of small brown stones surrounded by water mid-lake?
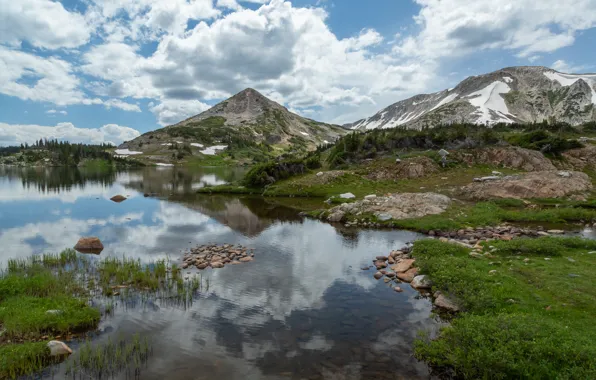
[182,244,255,270]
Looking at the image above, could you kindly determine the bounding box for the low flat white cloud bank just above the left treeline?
[0,123,140,146]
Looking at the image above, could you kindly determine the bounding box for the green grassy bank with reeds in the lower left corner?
[0,249,201,379]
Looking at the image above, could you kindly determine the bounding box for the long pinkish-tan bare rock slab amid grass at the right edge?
[459,171,592,200]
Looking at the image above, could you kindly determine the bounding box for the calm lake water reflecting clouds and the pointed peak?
[0,168,437,380]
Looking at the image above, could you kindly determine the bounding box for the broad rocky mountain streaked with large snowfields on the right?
[344,66,596,130]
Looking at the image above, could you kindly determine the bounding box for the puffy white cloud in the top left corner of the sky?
[0,0,90,49]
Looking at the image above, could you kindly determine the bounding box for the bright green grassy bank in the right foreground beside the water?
[414,238,596,379]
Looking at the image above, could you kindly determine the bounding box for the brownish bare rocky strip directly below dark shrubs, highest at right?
[449,146,556,172]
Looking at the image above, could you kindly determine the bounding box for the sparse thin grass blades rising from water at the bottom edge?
[66,334,152,380]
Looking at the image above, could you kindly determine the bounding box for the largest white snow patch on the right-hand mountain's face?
[468,81,513,124]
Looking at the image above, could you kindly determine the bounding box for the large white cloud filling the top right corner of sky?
[396,0,596,58]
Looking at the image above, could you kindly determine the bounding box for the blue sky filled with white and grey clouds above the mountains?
[0,0,596,146]
